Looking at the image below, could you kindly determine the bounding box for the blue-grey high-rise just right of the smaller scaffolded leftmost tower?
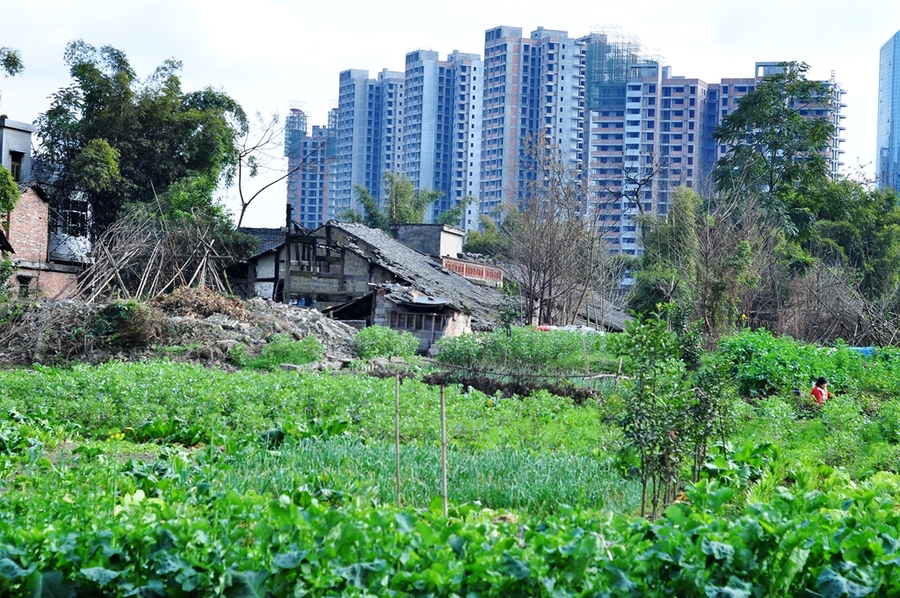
[335,69,404,214]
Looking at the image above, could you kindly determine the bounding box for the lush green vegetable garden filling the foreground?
[0,319,900,597]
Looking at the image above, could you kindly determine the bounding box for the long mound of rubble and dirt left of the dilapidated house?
[0,288,356,367]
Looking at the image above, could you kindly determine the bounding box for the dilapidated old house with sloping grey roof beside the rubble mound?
[284,221,501,352]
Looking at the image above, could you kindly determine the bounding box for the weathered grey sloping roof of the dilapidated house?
[325,220,502,325]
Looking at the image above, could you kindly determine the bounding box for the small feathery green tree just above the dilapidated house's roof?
[341,172,442,234]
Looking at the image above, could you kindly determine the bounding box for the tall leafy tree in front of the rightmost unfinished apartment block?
[713,62,834,239]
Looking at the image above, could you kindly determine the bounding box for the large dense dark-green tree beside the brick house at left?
[35,41,247,234]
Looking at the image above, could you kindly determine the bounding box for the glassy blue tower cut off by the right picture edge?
[875,31,900,190]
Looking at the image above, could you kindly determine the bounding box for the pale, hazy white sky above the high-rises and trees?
[0,0,900,227]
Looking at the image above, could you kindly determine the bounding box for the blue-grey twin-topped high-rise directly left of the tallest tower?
[395,50,484,228]
